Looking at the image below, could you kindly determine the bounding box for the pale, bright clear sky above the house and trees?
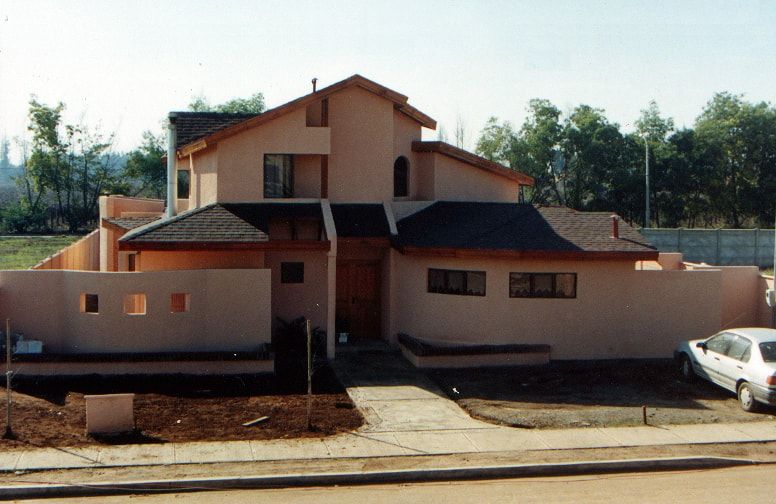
[0,0,776,161]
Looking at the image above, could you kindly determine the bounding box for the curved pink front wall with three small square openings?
[0,269,272,354]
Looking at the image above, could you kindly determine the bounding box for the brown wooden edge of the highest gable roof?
[175,74,436,156]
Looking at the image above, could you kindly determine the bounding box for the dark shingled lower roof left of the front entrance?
[120,203,322,243]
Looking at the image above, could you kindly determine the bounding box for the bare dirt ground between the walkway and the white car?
[429,360,776,428]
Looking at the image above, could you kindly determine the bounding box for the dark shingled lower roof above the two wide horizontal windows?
[394,201,657,255]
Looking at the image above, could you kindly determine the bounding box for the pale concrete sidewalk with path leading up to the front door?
[0,351,776,471]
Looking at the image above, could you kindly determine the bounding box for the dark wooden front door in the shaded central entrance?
[337,261,380,341]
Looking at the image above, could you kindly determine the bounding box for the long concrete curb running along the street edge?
[0,457,760,500]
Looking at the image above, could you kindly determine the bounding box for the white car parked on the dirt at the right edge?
[674,327,776,411]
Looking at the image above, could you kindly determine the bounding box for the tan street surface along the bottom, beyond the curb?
[24,465,776,504]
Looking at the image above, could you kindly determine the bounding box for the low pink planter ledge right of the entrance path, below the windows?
[398,334,550,368]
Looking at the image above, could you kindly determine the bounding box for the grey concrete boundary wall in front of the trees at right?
[640,228,774,268]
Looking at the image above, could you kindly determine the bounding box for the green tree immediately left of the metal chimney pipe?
[124,131,167,198]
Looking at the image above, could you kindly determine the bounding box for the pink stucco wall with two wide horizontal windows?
[391,252,722,359]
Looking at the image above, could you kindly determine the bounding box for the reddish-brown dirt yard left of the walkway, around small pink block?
[0,367,363,450]
